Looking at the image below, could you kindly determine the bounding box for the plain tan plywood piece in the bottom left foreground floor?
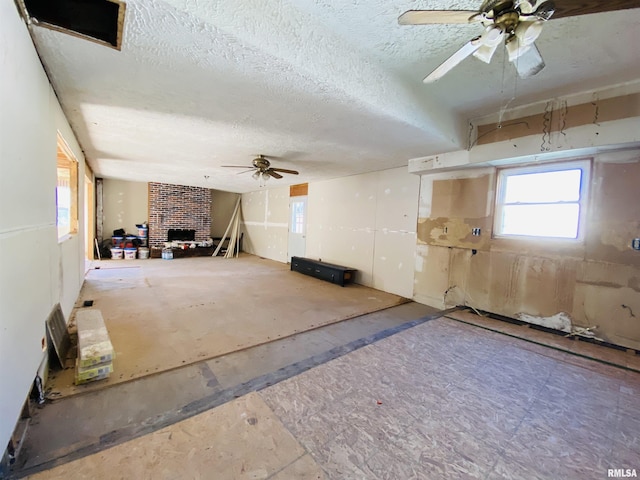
[27,393,326,480]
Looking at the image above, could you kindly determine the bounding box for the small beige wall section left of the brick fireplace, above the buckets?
[102,178,149,237]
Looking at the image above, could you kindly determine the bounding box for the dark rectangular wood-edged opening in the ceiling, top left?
[22,0,125,50]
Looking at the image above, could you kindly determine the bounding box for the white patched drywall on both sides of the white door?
[242,167,420,298]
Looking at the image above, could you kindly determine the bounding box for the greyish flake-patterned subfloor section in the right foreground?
[260,318,640,480]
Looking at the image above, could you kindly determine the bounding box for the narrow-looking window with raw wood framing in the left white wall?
[56,137,78,240]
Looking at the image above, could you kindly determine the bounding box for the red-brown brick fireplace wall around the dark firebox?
[149,183,211,247]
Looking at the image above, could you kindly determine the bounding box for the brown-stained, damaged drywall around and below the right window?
[415,150,640,349]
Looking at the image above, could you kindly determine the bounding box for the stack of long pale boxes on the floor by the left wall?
[75,309,115,385]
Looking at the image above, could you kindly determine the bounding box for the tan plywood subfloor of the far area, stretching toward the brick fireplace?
[47,255,406,398]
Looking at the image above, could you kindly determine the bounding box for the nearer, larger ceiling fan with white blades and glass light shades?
[398,0,640,83]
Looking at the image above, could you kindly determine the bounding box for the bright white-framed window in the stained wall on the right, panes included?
[494,160,590,239]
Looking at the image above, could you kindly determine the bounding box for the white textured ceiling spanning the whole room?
[32,0,640,192]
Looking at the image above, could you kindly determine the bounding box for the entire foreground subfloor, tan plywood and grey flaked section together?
[26,318,640,480]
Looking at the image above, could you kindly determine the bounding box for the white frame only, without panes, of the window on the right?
[493,158,593,243]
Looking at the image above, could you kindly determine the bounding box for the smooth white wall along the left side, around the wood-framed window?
[0,2,84,450]
